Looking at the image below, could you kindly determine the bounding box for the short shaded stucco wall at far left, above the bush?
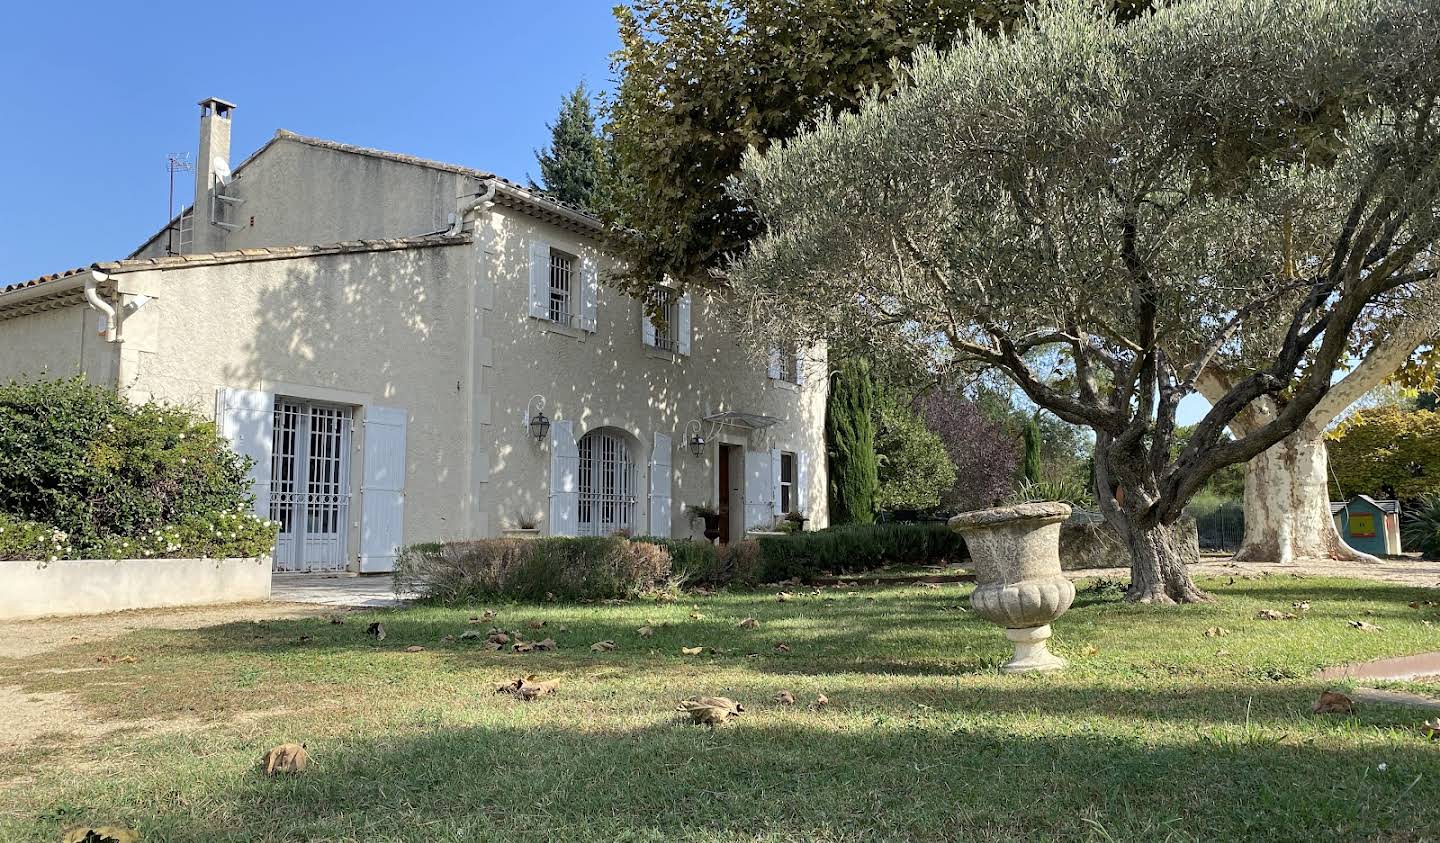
[0,304,115,386]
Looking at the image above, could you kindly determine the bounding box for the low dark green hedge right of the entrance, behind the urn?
[759,523,965,582]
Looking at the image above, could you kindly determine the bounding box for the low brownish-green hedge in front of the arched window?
[395,536,671,602]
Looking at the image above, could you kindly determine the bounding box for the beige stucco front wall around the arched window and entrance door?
[477,209,828,536]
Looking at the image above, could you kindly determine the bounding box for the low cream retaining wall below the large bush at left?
[0,559,271,620]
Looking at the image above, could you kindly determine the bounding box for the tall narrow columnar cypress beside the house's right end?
[825,357,880,525]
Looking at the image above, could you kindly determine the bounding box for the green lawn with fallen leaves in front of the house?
[0,576,1440,843]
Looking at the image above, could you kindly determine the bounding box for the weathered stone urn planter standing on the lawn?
[950,501,1076,673]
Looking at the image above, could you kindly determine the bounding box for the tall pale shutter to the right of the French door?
[360,406,408,574]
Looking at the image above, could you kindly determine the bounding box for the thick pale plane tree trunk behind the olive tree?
[1234,422,1378,565]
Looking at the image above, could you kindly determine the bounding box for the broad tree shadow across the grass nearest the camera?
[22,708,1440,843]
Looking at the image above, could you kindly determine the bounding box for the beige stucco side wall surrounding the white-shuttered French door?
[115,245,478,561]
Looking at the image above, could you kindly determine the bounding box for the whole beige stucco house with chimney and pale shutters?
[0,99,827,572]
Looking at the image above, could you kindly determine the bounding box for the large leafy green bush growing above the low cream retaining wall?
[0,379,275,559]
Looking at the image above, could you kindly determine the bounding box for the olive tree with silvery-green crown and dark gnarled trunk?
[730,0,1440,602]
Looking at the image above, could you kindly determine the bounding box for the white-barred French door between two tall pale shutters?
[271,396,351,572]
